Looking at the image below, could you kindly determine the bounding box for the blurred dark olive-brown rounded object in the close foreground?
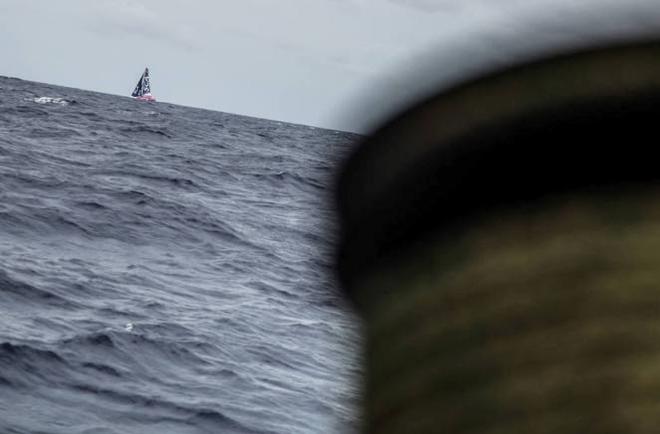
[338,41,660,434]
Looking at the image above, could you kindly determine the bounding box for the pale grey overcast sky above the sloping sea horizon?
[0,0,660,131]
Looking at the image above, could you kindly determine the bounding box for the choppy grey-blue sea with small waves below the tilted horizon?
[0,78,360,434]
